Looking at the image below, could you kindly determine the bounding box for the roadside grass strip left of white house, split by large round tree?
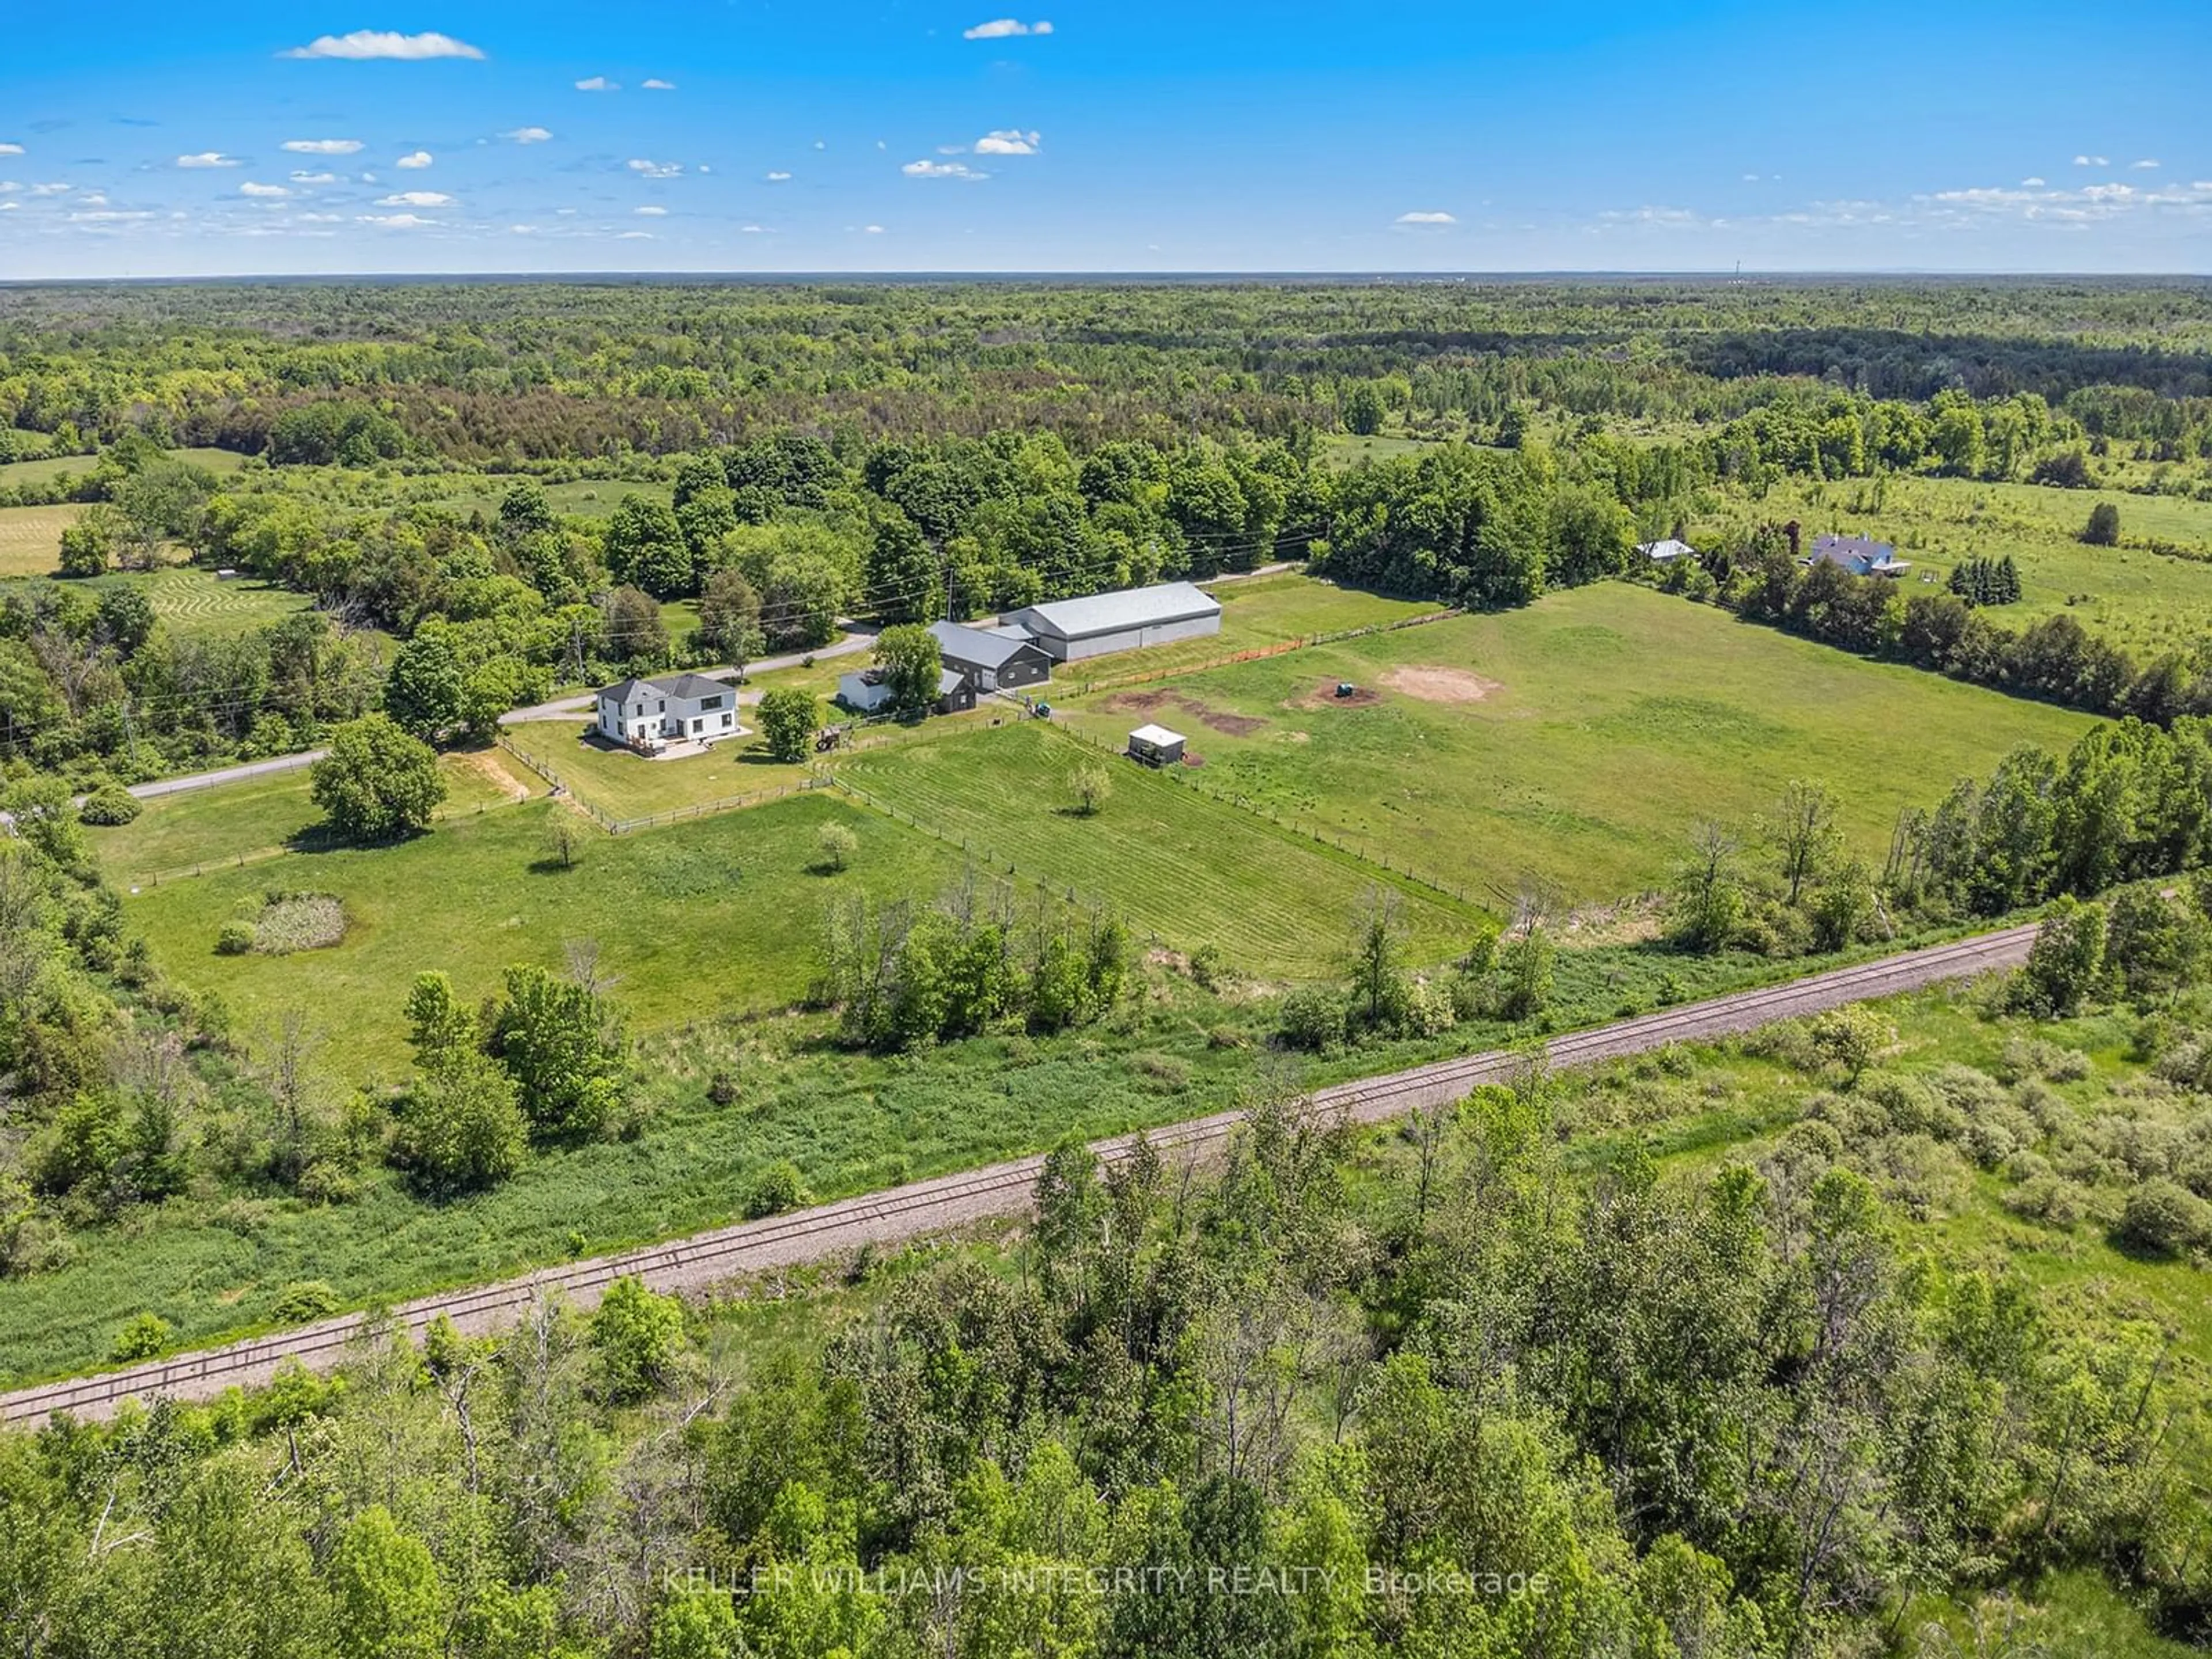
[84,754,544,887]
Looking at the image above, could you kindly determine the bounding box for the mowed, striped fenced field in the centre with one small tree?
[834,721,1482,980]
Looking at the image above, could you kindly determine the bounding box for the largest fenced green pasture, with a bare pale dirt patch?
[1058,582,2090,903]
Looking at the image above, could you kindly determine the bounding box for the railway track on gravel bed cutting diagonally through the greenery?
[0,922,2035,1422]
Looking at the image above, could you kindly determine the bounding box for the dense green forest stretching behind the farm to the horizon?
[0,283,2212,783]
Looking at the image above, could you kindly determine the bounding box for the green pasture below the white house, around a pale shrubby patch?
[124,792,960,1082]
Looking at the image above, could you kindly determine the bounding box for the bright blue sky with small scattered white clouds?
[0,0,2212,279]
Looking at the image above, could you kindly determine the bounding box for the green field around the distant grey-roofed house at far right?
[1690,478,2212,659]
